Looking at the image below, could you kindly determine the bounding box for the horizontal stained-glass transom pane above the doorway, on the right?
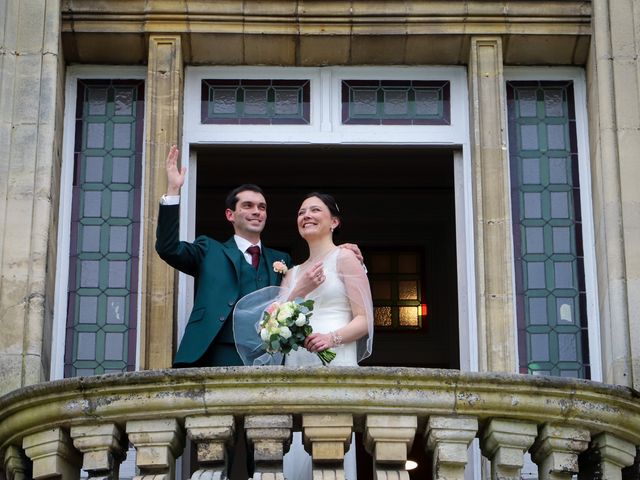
[342,80,451,125]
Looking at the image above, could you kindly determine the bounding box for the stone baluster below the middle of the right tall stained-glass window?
[531,424,590,480]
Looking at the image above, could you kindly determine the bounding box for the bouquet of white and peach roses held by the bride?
[258,298,336,365]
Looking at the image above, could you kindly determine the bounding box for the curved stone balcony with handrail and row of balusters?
[0,367,640,480]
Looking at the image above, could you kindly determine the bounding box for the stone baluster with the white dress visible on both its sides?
[302,414,353,480]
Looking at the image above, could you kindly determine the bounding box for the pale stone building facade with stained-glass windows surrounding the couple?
[0,0,640,478]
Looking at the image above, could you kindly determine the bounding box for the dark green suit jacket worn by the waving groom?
[156,205,291,367]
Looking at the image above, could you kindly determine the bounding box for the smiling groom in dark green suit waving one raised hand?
[156,145,291,368]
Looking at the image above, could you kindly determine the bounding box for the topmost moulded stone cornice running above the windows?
[62,0,591,35]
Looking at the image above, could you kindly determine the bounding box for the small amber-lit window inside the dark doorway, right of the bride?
[367,250,427,330]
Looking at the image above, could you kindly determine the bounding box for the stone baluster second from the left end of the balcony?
[22,428,81,480]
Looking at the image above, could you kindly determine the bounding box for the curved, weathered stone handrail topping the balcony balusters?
[0,367,640,449]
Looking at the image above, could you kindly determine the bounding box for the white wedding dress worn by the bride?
[284,248,358,480]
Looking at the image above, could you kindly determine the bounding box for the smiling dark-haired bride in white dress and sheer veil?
[234,192,373,480]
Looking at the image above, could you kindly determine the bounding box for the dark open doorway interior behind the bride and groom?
[195,145,460,369]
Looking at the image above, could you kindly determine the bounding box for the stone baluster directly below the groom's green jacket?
[184,415,235,479]
